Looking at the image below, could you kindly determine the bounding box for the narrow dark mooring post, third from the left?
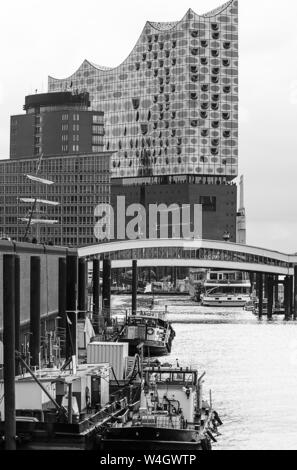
[58,258,67,356]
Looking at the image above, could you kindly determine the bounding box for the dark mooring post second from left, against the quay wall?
[30,256,41,366]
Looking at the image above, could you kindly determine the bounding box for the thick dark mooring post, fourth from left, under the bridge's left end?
[66,255,78,358]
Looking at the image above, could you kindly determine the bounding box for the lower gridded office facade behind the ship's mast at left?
[0,152,111,246]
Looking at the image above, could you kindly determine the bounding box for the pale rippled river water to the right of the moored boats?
[113,296,297,450]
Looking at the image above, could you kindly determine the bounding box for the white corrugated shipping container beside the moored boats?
[87,341,129,380]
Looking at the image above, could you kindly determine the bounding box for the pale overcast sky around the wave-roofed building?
[0,0,297,253]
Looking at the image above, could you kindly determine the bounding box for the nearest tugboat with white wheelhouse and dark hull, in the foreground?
[101,365,222,452]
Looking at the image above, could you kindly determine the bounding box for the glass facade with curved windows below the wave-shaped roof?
[48,0,238,180]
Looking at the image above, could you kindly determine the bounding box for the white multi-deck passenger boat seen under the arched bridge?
[201,271,251,307]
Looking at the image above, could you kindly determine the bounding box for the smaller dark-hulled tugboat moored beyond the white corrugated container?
[117,311,175,357]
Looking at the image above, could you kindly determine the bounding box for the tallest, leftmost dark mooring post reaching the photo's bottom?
[3,255,16,450]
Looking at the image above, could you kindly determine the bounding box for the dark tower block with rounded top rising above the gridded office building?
[10,91,104,159]
